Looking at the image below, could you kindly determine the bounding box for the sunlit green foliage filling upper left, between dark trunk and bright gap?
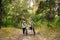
[2,0,30,26]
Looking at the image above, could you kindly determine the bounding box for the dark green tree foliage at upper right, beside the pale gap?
[36,0,55,21]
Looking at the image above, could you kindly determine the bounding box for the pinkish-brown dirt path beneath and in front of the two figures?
[17,30,46,40]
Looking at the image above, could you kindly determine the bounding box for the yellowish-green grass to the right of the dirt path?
[37,25,60,40]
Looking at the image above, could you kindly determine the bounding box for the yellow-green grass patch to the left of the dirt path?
[0,27,20,40]
